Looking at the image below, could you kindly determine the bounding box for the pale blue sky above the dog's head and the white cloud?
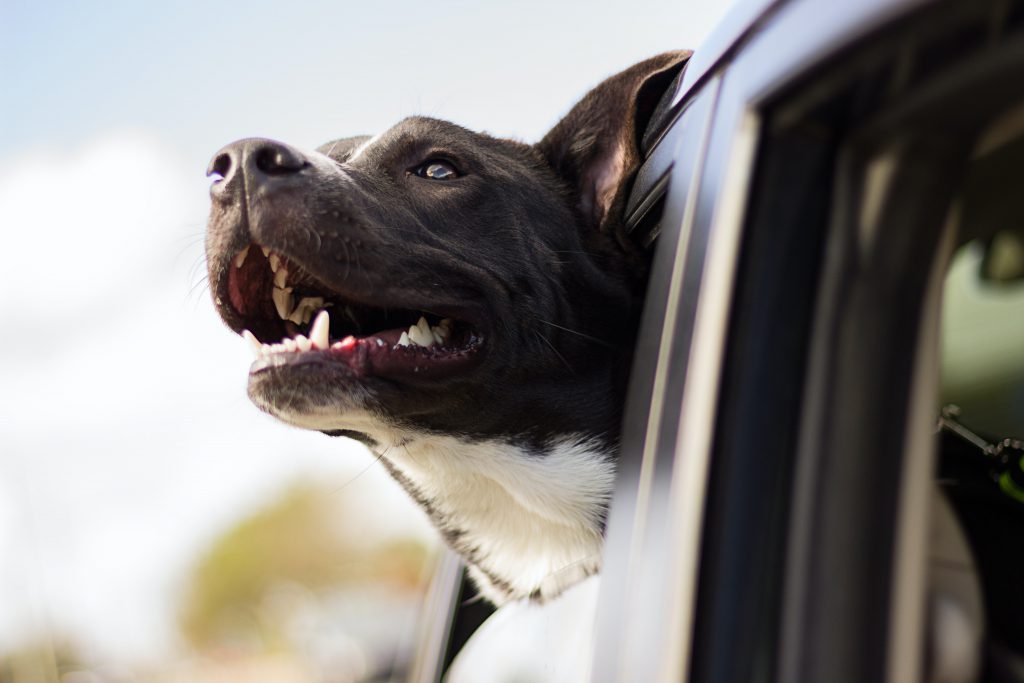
[0,0,726,160]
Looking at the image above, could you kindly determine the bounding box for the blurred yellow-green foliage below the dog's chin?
[180,484,427,649]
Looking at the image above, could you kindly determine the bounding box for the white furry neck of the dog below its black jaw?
[374,434,614,604]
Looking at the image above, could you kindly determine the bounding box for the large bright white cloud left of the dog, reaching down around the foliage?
[0,133,432,656]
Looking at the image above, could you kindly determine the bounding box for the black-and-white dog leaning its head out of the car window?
[206,51,690,605]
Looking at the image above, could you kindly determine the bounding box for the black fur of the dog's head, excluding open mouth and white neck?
[207,52,689,597]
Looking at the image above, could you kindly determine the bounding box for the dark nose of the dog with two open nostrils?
[206,138,309,197]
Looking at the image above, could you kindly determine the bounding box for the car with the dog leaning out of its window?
[401,0,1024,683]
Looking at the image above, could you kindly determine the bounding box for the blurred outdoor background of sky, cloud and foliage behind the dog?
[0,0,730,683]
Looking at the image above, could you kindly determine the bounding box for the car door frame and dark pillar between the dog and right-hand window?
[594,0,1024,681]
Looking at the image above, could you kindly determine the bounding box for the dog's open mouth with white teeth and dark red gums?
[225,245,483,380]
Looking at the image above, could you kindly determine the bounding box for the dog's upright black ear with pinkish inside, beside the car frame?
[537,50,691,235]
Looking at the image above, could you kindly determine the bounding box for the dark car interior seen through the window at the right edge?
[928,102,1024,681]
